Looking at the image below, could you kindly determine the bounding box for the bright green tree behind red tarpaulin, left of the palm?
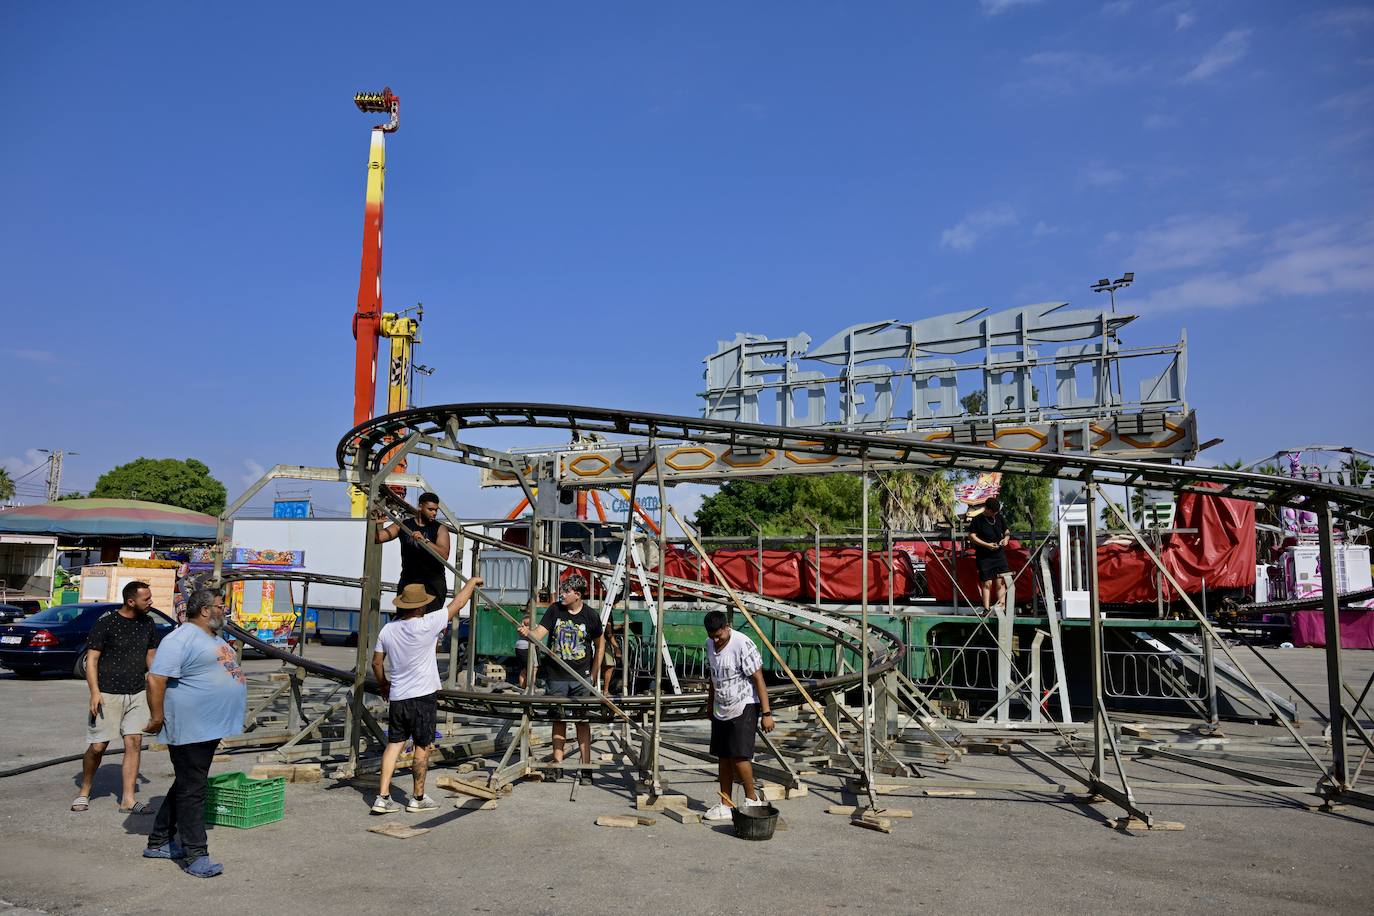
[697,474,881,537]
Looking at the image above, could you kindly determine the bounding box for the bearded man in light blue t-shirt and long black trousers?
[143,589,249,878]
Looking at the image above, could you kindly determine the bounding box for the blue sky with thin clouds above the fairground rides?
[0,0,1374,514]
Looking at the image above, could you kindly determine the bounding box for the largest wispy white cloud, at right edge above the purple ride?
[1140,224,1374,313]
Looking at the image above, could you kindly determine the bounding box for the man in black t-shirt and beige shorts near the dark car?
[71,582,158,814]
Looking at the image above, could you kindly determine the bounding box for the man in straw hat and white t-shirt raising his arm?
[372,575,482,814]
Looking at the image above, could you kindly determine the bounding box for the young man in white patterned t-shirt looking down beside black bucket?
[705,611,774,821]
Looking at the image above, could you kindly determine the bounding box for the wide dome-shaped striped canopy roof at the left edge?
[0,500,217,541]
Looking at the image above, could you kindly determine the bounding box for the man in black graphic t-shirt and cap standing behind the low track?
[517,575,606,786]
